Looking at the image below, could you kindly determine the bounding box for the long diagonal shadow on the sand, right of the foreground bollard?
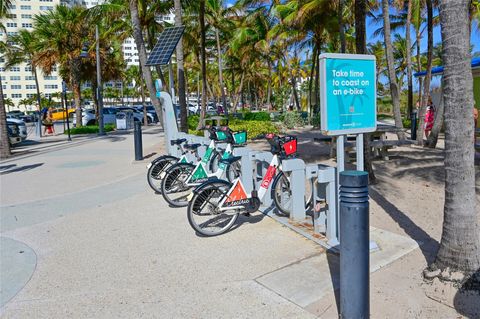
[369,187,439,264]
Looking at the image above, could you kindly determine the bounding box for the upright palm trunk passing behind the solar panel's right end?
[174,0,188,133]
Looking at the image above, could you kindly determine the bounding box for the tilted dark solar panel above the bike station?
[147,26,185,65]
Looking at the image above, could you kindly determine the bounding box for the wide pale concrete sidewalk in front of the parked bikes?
[0,129,468,318]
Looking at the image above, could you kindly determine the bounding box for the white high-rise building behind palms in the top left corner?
[0,0,62,111]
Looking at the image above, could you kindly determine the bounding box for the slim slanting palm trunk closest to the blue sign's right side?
[382,0,405,140]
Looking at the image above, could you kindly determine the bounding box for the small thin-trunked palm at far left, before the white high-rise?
[5,29,42,115]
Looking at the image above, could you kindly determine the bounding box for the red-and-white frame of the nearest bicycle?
[218,154,281,211]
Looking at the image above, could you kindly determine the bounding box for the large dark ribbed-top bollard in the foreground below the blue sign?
[339,171,370,319]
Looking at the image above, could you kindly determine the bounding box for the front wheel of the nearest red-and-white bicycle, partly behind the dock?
[272,172,313,216]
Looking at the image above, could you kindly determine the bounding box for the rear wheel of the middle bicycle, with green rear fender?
[162,163,195,207]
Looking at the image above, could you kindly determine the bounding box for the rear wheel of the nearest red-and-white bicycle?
[187,180,240,237]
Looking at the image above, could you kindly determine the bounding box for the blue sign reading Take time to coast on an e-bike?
[320,53,377,135]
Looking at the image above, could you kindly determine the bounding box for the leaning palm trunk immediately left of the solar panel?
[129,0,165,128]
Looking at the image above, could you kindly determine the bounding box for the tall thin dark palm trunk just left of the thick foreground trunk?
[417,0,436,145]
